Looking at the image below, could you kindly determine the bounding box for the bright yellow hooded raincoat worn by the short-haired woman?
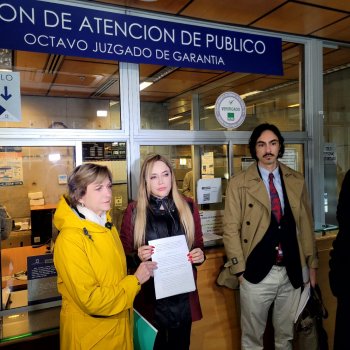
[54,197,140,350]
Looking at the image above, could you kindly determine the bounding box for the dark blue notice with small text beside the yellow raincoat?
[27,254,61,305]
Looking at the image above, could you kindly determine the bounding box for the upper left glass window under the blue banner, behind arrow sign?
[0,49,121,130]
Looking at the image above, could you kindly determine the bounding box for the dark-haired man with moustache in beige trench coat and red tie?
[223,123,318,350]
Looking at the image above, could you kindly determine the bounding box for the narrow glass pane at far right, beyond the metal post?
[323,47,350,225]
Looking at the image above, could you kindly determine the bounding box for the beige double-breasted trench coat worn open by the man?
[223,163,318,282]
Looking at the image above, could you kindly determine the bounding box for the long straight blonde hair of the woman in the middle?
[134,154,194,249]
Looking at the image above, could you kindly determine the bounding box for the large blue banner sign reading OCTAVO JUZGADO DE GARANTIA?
[0,0,283,75]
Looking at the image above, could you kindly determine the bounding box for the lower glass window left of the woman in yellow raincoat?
[0,146,75,310]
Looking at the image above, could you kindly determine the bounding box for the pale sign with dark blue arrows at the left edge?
[0,71,22,122]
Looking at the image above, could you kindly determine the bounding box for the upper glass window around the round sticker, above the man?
[140,43,305,131]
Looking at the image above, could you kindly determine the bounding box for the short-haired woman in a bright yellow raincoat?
[54,164,156,350]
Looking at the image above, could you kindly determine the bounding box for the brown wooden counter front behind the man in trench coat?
[190,232,336,350]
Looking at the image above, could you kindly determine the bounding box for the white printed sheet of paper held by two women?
[148,235,196,299]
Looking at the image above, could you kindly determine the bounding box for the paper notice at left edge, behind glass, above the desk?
[0,147,23,186]
